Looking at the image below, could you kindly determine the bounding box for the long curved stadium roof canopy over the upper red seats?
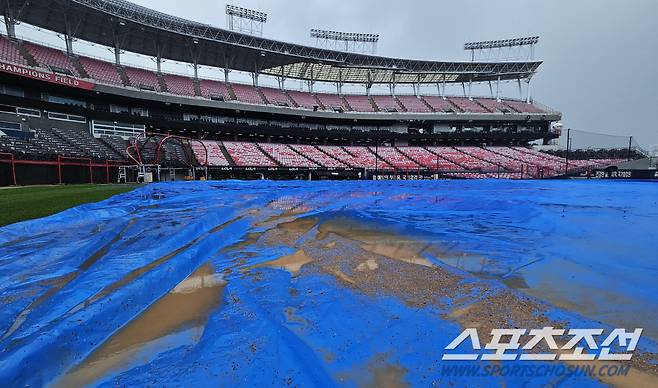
[1,0,541,85]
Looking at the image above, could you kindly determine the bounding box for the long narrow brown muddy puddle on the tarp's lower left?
[55,264,226,387]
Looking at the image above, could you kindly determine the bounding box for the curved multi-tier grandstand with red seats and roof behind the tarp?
[0,0,640,185]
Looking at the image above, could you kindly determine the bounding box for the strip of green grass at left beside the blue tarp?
[0,185,137,226]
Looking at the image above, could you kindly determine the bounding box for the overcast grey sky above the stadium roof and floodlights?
[9,0,658,146]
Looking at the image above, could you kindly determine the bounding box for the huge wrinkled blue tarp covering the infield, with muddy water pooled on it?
[0,180,658,386]
